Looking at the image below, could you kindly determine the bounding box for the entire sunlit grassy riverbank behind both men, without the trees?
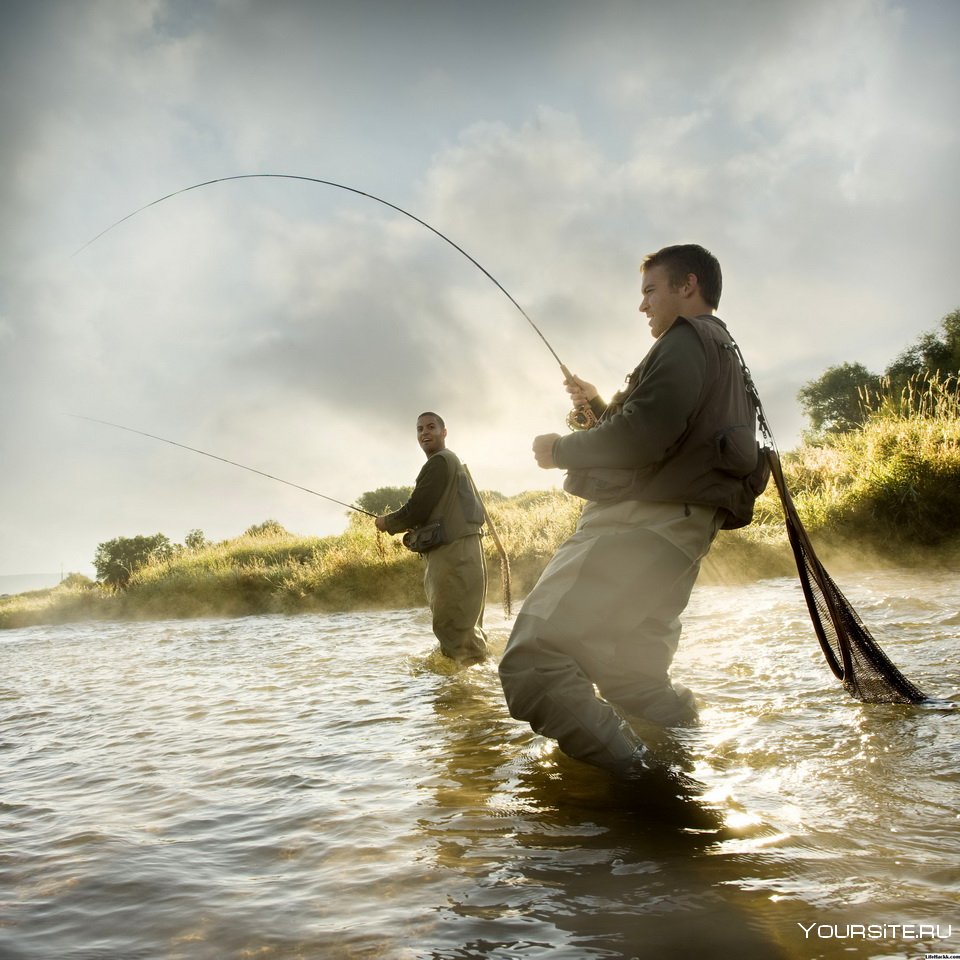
[7,381,960,628]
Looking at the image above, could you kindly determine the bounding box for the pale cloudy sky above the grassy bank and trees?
[0,0,960,575]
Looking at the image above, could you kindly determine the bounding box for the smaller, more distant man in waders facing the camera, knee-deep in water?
[374,412,487,665]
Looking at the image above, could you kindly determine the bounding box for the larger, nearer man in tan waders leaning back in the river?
[500,244,759,779]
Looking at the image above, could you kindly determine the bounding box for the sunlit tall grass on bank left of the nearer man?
[0,491,580,627]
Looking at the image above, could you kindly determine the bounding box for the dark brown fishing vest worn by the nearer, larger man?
[564,315,769,530]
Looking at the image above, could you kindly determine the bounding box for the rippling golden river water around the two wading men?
[0,572,960,960]
